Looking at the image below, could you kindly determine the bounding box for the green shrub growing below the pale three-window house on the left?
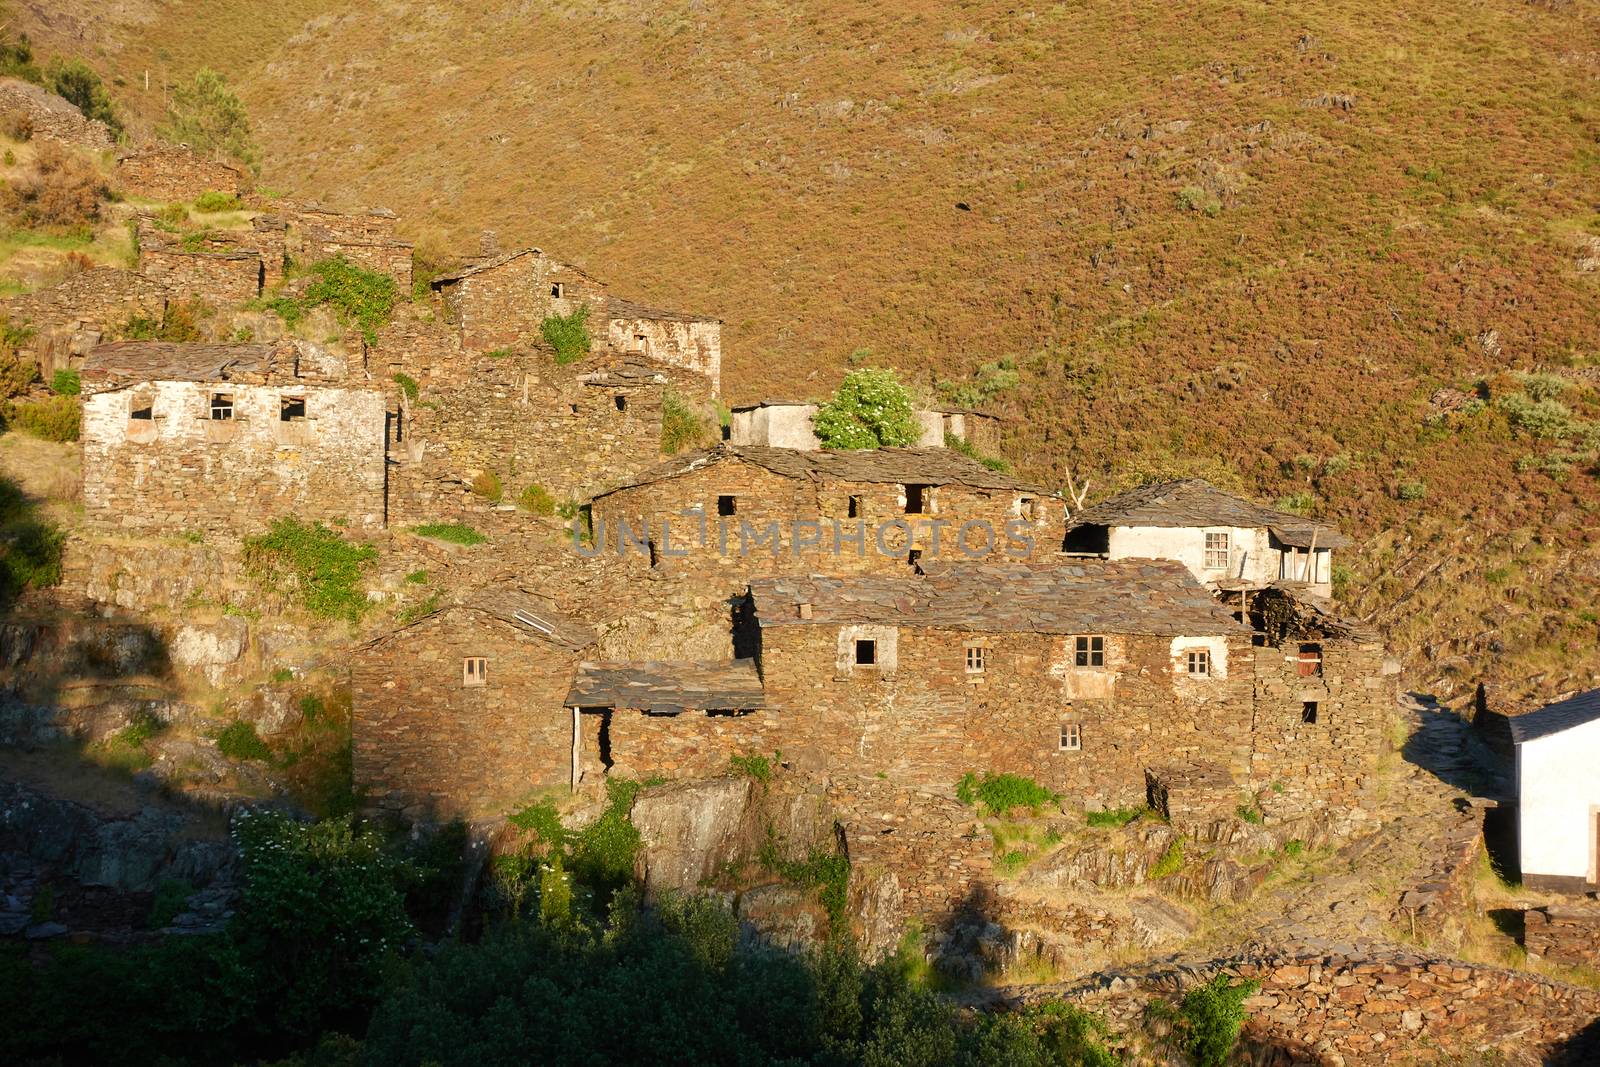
[243,518,378,622]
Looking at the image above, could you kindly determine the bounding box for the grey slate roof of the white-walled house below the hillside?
[1070,478,1350,549]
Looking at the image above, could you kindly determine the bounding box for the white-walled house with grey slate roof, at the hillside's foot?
[1062,478,1350,597]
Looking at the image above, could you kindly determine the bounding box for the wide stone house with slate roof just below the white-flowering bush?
[592,445,1062,592]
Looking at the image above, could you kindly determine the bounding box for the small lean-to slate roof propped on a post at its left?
[566,659,766,713]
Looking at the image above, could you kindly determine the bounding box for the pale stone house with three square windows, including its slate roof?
[80,341,384,533]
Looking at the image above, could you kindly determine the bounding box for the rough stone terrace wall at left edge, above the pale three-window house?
[0,267,166,379]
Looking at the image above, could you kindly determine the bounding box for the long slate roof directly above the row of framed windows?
[750,560,1248,637]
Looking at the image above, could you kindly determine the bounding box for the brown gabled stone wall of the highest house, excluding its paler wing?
[438,253,605,352]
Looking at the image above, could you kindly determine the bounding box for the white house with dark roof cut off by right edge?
[1510,689,1600,893]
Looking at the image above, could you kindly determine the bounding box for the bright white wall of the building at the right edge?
[1517,720,1600,881]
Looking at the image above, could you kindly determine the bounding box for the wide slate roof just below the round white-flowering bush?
[600,445,1056,496]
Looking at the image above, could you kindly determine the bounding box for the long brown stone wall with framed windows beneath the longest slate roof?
[762,625,1250,806]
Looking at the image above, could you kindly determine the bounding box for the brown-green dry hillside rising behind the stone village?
[19,0,1600,710]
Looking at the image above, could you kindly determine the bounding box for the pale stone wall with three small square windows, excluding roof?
[82,381,384,533]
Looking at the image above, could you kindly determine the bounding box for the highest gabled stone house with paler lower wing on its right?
[432,248,722,395]
